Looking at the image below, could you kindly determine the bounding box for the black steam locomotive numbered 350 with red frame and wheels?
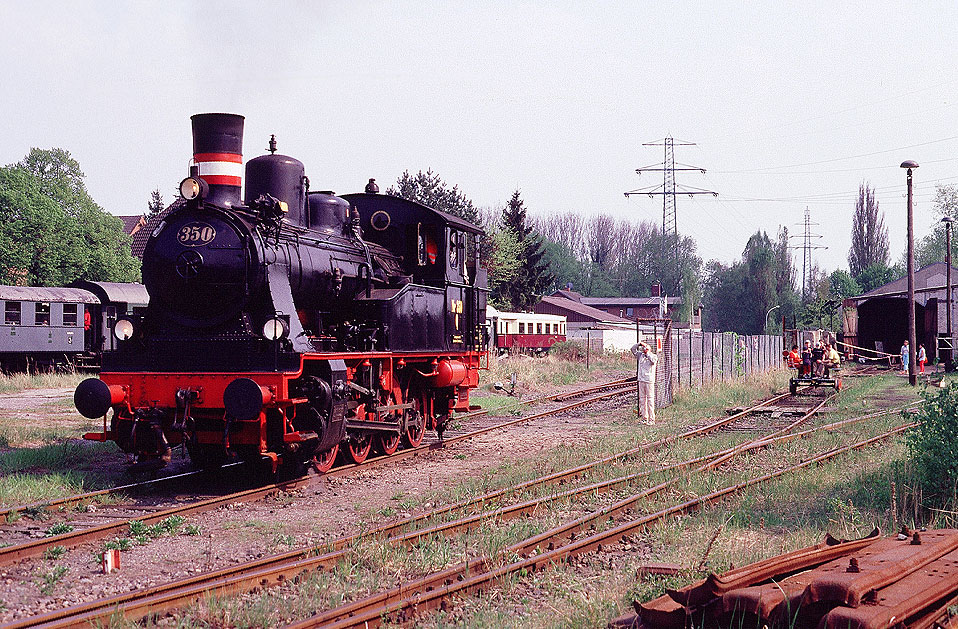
[74,114,488,471]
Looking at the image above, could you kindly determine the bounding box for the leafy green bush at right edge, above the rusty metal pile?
[906,383,958,506]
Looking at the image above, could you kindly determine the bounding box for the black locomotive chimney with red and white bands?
[190,114,244,206]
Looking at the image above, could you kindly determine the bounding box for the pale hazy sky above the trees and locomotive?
[0,0,958,271]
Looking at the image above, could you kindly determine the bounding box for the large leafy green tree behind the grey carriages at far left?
[0,149,140,285]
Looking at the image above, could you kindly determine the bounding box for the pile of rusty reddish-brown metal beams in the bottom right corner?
[635,529,958,629]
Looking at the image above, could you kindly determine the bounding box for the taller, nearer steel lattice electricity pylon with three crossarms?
[625,137,718,295]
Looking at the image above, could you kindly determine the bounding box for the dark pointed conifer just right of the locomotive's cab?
[493,190,555,311]
